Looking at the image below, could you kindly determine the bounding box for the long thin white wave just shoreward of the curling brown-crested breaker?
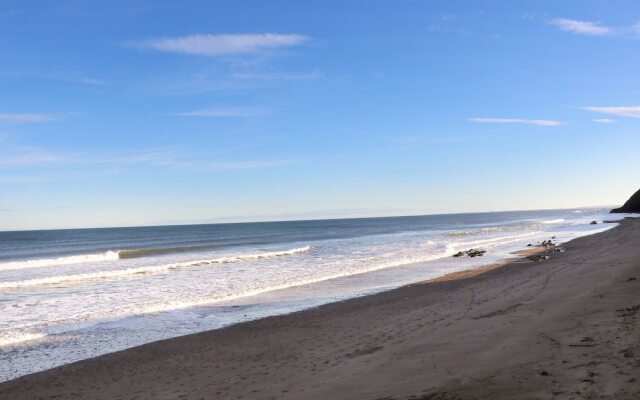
[0,246,311,289]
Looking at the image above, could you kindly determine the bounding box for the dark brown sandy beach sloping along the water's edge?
[0,219,640,400]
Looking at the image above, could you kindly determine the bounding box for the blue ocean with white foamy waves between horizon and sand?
[0,208,624,381]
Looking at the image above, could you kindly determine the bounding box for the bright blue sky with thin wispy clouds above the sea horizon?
[0,0,640,230]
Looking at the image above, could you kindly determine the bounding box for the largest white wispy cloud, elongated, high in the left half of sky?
[126,33,309,56]
